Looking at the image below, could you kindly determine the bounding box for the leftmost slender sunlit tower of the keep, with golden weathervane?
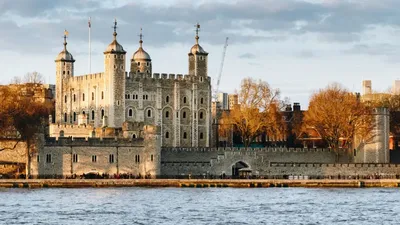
[55,30,75,123]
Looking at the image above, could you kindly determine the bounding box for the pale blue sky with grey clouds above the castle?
[0,0,400,109]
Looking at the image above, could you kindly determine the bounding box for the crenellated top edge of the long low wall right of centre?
[162,147,332,154]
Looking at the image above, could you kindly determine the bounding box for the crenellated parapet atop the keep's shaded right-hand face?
[125,72,211,82]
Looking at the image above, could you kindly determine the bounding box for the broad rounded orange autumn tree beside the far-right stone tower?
[303,84,373,156]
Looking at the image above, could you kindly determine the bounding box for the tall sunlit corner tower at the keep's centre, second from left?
[104,20,126,127]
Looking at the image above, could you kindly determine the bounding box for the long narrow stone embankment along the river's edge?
[0,179,400,188]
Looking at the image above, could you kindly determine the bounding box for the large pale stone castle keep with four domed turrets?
[50,21,211,147]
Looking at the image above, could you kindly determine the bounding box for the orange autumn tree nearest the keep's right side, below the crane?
[219,78,285,148]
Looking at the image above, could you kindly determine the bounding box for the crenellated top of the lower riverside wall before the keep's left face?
[44,137,144,147]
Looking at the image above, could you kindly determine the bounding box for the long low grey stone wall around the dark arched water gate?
[161,148,352,176]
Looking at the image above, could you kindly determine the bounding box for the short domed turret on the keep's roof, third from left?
[130,29,152,75]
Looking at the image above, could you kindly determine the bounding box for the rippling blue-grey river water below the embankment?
[0,188,400,225]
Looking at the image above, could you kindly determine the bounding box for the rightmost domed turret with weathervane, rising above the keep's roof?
[188,24,208,77]
